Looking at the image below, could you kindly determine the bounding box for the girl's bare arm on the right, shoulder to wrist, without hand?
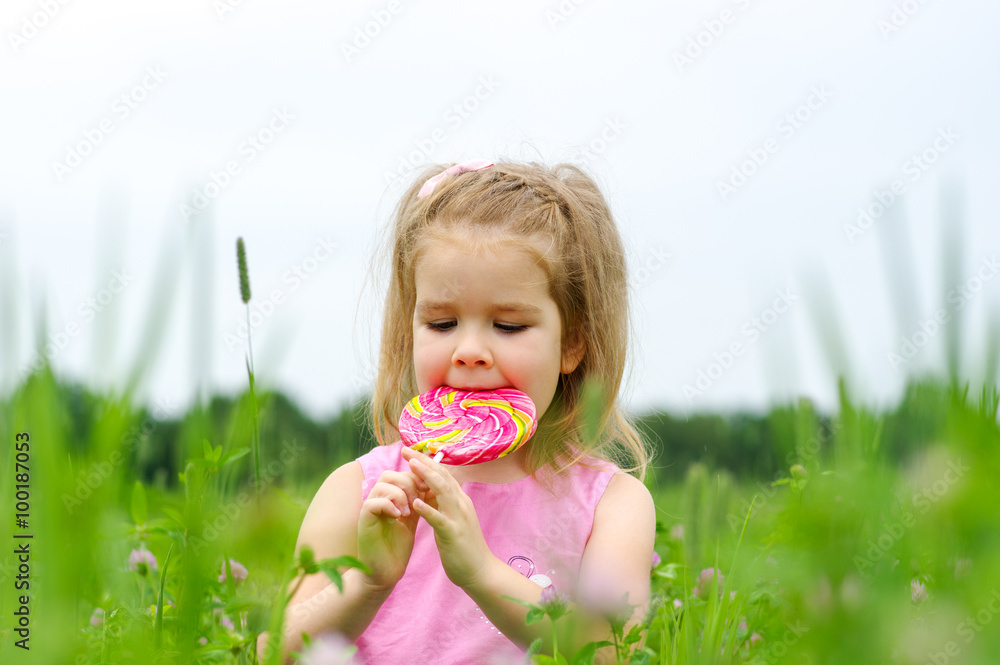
[465,473,656,662]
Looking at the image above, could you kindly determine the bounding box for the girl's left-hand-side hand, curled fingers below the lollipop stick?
[358,471,427,589]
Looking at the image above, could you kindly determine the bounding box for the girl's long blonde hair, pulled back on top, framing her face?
[371,162,650,486]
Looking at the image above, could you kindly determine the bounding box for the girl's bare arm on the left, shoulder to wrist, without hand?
[257,461,402,663]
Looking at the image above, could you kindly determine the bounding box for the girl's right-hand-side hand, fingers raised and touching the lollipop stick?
[403,446,493,589]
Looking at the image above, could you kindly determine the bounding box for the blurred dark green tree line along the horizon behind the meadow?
[50,382,945,490]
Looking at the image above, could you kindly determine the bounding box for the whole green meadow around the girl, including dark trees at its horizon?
[0,236,1000,665]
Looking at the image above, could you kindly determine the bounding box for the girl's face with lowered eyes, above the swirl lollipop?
[413,236,584,418]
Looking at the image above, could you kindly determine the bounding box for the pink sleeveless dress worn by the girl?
[356,442,619,665]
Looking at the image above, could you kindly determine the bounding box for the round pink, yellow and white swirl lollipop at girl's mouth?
[399,386,536,465]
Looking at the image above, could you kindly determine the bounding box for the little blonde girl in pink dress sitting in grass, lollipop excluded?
[258,162,656,665]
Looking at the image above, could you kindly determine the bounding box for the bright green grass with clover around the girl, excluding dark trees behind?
[0,370,1000,664]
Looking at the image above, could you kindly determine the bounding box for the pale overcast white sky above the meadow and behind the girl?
[0,0,1000,416]
